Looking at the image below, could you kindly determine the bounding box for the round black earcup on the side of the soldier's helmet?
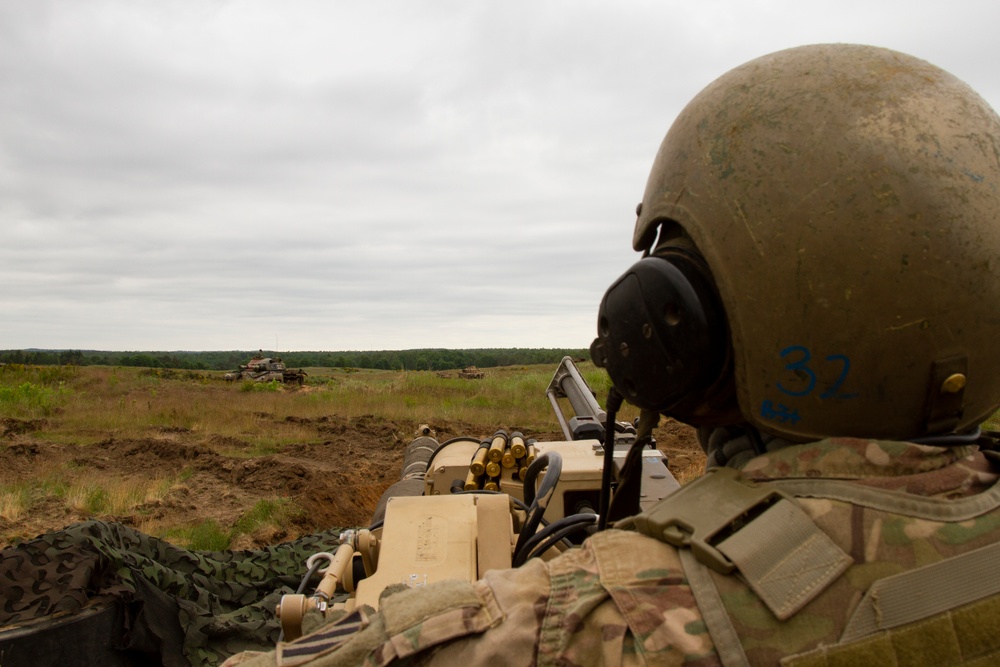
[591,252,729,413]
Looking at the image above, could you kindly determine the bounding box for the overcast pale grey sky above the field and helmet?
[0,0,1000,351]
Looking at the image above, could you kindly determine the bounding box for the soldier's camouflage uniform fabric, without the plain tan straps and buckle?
[228,439,1000,665]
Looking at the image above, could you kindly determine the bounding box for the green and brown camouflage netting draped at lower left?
[0,521,339,665]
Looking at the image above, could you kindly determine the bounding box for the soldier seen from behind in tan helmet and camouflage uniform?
[232,45,1000,666]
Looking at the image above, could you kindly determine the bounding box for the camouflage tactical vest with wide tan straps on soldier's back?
[619,468,1000,667]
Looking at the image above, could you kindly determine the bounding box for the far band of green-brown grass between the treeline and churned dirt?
[0,363,626,446]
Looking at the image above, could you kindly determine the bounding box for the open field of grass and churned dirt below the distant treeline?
[0,363,664,548]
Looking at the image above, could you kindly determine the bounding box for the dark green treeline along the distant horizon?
[0,348,588,371]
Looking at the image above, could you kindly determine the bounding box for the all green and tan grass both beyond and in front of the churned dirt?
[0,364,620,550]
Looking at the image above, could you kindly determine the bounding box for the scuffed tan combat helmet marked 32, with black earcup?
[591,44,1000,441]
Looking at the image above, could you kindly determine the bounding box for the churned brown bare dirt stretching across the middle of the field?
[0,416,704,549]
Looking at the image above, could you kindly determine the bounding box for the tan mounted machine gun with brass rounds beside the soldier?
[277,357,679,640]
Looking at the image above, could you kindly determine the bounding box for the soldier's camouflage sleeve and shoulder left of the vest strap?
[230,531,719,667]
